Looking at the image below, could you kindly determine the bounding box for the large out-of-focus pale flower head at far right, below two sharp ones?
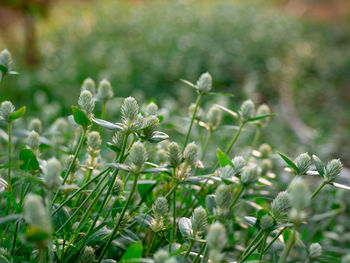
[289,177,311,211]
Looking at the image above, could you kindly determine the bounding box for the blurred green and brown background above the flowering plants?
[0,0,350,166]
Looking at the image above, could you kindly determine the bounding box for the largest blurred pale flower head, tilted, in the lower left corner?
[23,194,52,235]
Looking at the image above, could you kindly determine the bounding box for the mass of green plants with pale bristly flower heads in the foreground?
[0,50,350,263]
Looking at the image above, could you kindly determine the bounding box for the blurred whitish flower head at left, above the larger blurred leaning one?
[43,158,62,190]
